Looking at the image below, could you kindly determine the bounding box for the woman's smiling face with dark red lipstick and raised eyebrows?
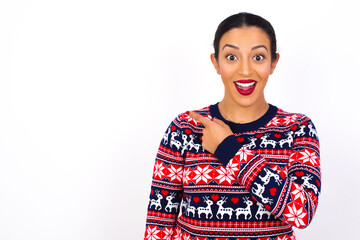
[211,27,279,107]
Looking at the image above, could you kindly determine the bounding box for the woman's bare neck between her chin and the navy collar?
[218,98,269,123]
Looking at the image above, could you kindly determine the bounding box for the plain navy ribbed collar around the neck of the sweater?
[210,103,278,133]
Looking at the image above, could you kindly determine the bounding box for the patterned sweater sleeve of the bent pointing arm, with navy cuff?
[215,116,321,228]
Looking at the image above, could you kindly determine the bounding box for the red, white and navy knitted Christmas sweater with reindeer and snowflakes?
[144,104,321,240]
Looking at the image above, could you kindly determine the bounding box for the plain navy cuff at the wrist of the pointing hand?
[214,135,241,166]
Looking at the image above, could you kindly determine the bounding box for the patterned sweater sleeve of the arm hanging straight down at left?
[144,117,184,240]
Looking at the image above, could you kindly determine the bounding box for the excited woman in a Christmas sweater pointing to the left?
[145,13,321,240]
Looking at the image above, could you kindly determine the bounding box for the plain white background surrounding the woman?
[0,0,360,240]
